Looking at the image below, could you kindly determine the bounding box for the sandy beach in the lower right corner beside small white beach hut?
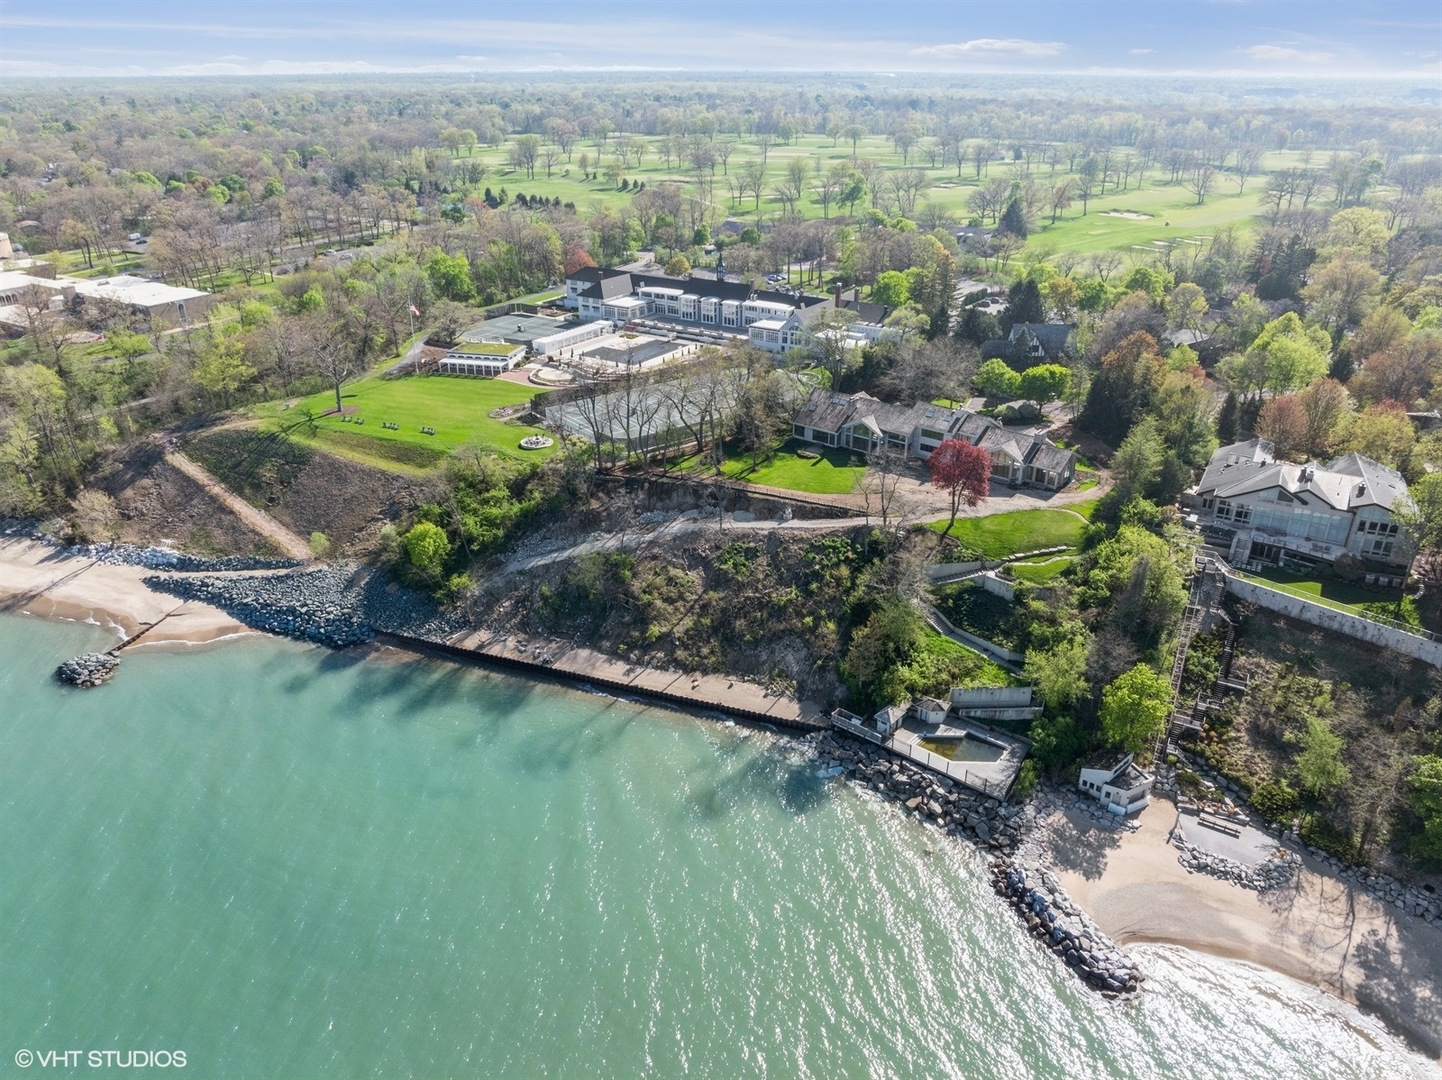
[1047,799,1442,1057]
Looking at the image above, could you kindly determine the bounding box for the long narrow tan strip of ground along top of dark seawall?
[426,630,829,730]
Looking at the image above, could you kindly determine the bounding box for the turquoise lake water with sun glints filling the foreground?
[0,617,1432,1080]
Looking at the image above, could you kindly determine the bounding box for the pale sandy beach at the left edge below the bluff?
[0,536,252,649]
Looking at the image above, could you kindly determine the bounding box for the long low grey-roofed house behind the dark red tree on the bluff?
[792,389,1077,492]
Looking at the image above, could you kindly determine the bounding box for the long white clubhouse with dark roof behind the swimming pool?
[561,267,891,352]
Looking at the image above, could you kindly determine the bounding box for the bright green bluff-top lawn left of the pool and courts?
[255,375,555,469]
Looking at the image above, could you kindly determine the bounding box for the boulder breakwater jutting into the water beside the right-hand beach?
[992,858,1146,998]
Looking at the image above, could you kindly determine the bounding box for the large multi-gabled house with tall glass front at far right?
[1184,438,1413,571]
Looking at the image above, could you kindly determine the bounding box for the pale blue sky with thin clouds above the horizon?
[0,0,1442,82]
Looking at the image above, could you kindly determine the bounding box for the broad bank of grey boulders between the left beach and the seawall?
[146,562,466,649]
